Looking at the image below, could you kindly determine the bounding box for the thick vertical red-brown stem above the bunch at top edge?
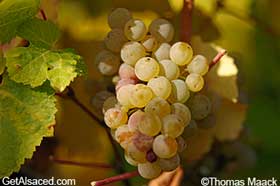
[181,0,194,42]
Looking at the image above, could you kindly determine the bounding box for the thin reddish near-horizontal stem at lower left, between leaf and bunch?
[49,156,113,169]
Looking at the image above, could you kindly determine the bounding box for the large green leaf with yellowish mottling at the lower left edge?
[0,77,56,178]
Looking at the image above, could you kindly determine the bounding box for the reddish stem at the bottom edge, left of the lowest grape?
[91,171,139,186]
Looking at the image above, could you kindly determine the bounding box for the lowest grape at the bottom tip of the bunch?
[138,162,161,179]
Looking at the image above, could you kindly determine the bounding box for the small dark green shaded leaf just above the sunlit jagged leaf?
[17,18,60,48]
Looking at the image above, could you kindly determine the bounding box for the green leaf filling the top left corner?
[0,0,40,43]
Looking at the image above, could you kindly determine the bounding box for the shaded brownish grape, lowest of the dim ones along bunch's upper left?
[95,50,120,76]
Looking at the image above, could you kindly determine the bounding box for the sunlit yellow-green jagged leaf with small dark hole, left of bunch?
[6,47,86,92]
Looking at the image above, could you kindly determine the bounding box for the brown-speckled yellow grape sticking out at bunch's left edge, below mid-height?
[104,108,128,129]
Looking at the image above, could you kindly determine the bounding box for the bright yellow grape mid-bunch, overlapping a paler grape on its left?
[129,84,154,108]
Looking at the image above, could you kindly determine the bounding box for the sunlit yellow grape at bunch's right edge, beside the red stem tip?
[187,55,209,76]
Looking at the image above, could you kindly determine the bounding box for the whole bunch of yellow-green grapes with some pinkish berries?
[96,8,212,179]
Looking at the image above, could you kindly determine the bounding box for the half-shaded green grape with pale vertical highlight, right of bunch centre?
[168,79,190,103]
